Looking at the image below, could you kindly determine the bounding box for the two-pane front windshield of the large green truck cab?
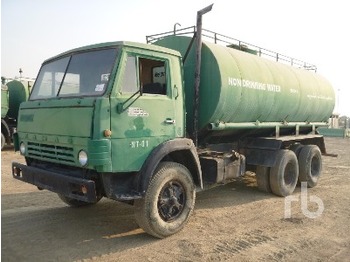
[30,48,117,100]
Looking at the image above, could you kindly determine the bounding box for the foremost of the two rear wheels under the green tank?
[270,150,299,197]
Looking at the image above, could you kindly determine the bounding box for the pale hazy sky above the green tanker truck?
[1,0,350,116]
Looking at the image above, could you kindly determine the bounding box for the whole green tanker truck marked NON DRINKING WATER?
[12,4,335,238]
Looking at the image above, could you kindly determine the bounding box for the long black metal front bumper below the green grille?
[12,162,97,203]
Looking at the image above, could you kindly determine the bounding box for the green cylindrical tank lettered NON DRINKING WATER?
[156,36,335,134]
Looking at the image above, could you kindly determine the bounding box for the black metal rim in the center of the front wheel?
[157,181,186,222]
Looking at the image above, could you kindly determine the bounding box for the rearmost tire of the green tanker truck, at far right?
[298,145,322,187]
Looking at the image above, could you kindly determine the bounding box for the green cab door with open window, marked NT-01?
[111,52,177,172]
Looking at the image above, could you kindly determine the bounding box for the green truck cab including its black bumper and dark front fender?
[13,42,201,237]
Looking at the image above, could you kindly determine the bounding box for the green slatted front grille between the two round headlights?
[28,142,75,164]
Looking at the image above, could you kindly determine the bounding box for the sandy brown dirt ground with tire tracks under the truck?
[1,138,350,261]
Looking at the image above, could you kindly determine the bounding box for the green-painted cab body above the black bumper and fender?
[16,42,185,172]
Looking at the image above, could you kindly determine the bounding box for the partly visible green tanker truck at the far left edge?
[1,77,34,150]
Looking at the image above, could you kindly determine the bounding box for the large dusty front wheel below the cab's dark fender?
[134,162,196,238]
